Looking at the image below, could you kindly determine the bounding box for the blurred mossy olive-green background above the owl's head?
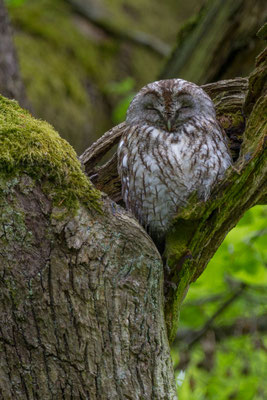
[5,0,266,154]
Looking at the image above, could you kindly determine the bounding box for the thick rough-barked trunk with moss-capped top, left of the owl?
[0,101,176,400]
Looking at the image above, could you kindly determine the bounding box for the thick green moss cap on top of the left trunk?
[0,96,100,211]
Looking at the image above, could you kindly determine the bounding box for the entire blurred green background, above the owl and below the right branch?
[5,0,267,400]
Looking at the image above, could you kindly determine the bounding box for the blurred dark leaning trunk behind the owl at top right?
[160,0,266,84]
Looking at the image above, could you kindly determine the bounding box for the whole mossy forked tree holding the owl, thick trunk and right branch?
[0,38,267,399]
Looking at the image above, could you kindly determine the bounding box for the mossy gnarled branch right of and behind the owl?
[81,50,267,338]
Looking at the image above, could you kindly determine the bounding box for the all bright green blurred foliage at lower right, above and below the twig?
[173,206,267,400]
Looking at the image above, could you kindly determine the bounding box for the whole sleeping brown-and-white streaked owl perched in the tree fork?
[118,79,231,238]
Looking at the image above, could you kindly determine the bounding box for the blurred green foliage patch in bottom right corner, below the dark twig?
[178,336,267,400]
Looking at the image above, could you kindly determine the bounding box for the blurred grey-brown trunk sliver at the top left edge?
[0,0,29,107]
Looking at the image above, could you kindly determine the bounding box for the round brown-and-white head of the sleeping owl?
[126,79,216,132]
